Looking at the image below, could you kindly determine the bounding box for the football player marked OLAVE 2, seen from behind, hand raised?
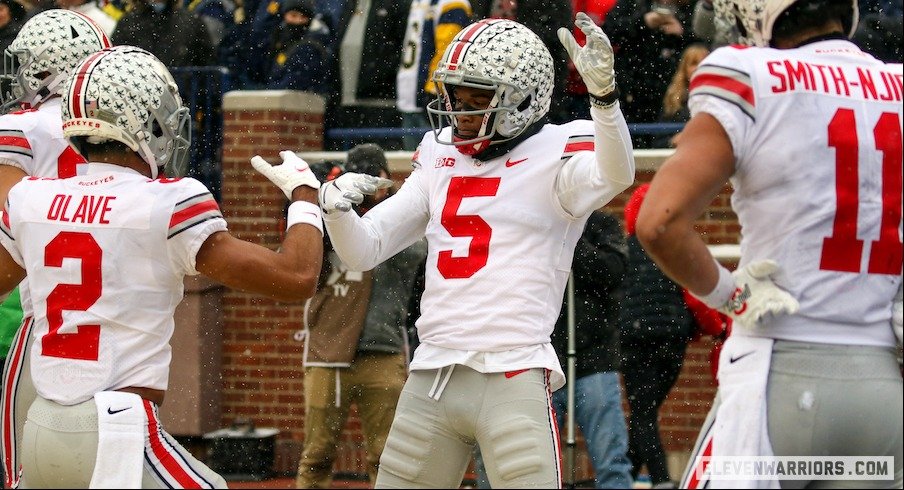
[0,46,323,488]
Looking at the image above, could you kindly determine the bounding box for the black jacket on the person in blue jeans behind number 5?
[552,211,628,378]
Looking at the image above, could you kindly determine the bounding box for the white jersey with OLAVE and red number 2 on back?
[0,164,226,405]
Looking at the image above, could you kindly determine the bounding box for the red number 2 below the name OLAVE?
[41,231,103,361]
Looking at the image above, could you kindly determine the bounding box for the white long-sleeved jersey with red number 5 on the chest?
[325,105,634,389]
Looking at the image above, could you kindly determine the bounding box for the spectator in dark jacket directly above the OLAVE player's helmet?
[110,0,213,68]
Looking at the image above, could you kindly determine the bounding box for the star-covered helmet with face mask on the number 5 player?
[427,19,554,155]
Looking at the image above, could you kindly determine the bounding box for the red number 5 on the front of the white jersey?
[436,177,500,279]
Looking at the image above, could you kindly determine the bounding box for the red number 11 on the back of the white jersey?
[819,109,902,274]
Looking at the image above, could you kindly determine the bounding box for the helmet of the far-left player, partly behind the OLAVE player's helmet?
[0,9,111,112]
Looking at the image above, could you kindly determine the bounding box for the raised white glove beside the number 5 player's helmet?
[558,12,615,98]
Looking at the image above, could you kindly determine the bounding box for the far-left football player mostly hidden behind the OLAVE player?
[0,9,110,488]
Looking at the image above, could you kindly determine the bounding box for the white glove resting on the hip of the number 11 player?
[719,260,800,330]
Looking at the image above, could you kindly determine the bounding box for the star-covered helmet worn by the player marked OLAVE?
[63,46,191,178]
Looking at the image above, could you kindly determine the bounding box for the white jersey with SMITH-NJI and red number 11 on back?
[689,40,904,346]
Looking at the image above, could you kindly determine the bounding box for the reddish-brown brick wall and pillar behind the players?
[215,91,738,479]
